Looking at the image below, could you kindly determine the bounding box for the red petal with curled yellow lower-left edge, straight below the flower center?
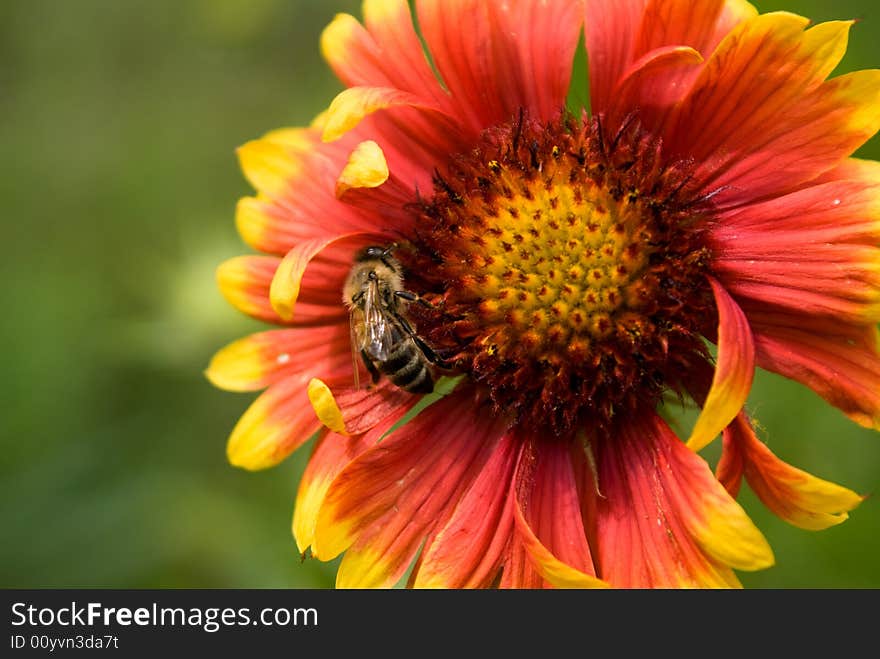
[511,442,608,588]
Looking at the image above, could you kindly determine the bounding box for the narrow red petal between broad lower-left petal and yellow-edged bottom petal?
[412,434,519,588]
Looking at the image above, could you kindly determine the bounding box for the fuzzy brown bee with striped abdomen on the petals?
[342,245,441,394]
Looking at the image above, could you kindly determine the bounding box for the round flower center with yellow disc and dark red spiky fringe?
[403,113,715,434]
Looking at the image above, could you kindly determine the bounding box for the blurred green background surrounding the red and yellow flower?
[0,0,880,588]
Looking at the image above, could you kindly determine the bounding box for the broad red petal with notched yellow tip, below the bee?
[313,395,502,588]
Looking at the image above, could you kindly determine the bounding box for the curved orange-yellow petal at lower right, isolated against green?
[727,415,864,531]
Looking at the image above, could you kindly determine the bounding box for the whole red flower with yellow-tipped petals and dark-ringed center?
[207,0,880,588]
